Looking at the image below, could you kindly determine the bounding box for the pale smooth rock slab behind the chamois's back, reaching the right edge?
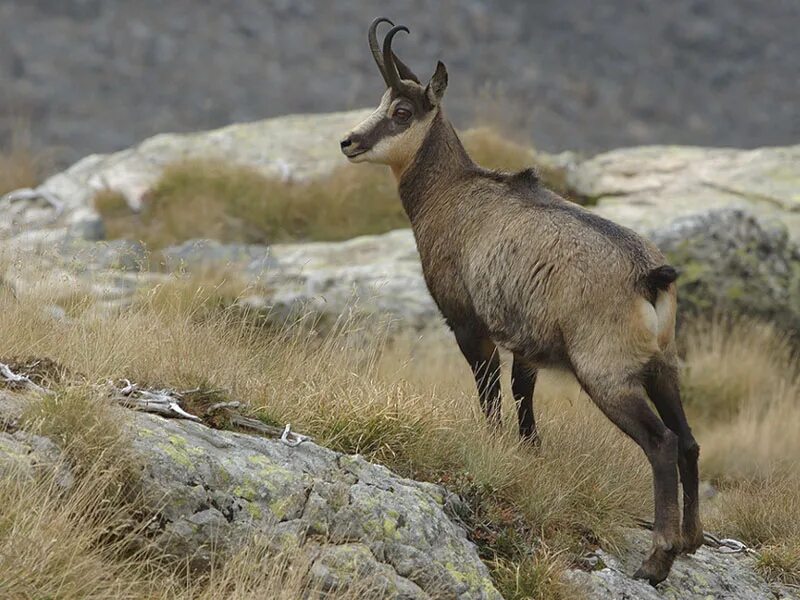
[567,145,800,243]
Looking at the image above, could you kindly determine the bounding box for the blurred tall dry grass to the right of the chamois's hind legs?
[683,319,800,584]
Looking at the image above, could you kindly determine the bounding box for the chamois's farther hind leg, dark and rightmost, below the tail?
[644,353,703,554]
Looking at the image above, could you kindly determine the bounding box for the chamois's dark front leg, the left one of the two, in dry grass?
[453,327,500,428]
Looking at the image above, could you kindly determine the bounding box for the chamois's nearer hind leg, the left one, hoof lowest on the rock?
[576,372,681,585]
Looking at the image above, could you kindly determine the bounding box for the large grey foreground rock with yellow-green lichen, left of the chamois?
[132,414,500,598]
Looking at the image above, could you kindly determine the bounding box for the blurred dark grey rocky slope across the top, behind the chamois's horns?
[0,0,800,166]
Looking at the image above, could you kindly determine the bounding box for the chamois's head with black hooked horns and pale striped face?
[341,17,447,174]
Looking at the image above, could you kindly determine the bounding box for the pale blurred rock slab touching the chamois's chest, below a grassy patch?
[156,229,439,328]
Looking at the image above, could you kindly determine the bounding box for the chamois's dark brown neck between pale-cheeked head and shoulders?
[398,111,475,220]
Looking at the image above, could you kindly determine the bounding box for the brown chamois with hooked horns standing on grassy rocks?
[341,17,703,585]
